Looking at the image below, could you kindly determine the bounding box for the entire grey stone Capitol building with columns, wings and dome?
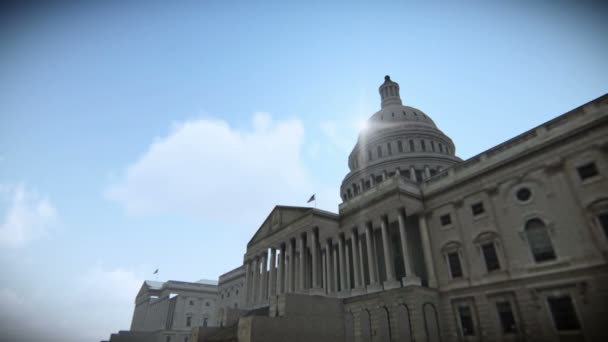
[110,76,608,342]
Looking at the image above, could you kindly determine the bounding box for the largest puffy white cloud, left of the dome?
[105,113,335,223]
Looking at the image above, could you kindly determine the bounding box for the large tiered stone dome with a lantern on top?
[340,75,460,201]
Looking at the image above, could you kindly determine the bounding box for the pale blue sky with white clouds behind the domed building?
[0,1,608,341]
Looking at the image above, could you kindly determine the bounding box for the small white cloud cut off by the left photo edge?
[0,183,57,247]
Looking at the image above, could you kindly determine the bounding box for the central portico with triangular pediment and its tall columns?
[244,182,436,307]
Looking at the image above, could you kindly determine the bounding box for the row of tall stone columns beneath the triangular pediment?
[245,210,436,307]
